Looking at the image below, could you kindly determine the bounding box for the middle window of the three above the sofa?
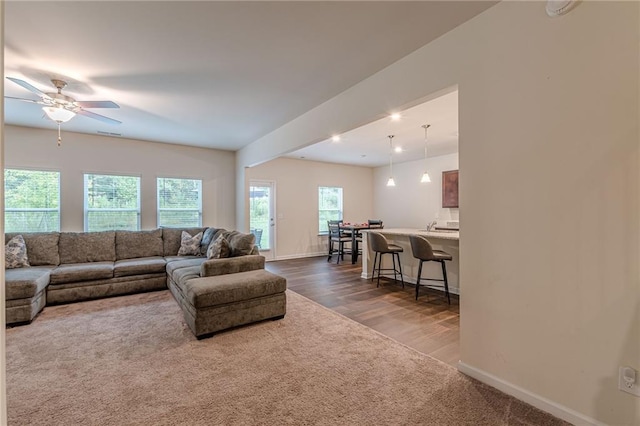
[84,174,140,232]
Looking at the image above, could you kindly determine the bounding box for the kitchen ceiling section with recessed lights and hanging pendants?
[287,90,458,167]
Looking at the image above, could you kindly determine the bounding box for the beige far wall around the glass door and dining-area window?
[246,158,373,259]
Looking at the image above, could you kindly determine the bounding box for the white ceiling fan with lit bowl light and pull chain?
[5,77,122,145]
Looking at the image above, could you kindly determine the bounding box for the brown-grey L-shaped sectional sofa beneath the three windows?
[5,228,286,337]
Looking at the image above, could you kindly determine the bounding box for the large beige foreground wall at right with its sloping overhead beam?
[236,1,640,425]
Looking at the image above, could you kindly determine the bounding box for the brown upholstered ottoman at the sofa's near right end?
[170,269,287,339]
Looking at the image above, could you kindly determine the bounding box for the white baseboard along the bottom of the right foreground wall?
[458,361,606,426]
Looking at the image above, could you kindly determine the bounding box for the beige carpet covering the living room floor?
[6,291,564,426]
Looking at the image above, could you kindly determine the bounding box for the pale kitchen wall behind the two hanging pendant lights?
[373,154,459,229]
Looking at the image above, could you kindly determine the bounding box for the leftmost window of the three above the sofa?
[4,169,60,232]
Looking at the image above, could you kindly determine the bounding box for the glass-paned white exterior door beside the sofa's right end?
[249,180,276,260]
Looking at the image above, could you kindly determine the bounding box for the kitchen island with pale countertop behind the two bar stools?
[361,228,460,294]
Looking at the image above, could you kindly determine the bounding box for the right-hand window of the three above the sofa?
[157,178,202,227]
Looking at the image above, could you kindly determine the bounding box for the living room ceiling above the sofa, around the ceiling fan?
[4,1,496,151]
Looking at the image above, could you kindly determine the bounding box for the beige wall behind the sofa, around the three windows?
[4,126,235,231]
